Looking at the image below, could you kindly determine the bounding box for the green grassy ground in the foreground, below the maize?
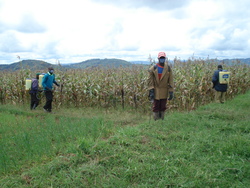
[0,92,250,188]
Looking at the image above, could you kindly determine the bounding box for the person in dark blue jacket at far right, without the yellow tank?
[212,65,228,103]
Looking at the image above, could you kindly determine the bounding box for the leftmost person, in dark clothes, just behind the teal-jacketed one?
[29,73,40,110]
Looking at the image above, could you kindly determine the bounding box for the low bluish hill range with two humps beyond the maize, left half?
[0,59,133,71]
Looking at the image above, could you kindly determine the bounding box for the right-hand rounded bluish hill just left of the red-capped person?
[62,59,133,69]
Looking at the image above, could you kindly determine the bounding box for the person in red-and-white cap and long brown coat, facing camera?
[148,52,174,120]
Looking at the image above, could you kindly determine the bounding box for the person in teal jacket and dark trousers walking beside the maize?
[42,67,59,112]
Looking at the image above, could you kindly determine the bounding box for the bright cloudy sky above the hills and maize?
[0,0,250,64]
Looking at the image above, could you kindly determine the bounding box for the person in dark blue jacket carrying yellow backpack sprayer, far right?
[212,65,229,103]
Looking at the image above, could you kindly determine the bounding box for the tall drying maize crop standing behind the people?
[0,59,250,112]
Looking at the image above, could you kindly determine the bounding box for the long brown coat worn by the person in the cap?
[148,63,174,100]
